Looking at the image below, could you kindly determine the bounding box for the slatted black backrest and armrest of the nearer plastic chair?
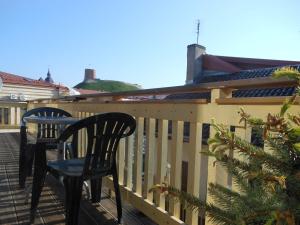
[59,112,136,179]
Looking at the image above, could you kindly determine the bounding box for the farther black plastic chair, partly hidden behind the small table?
[19,107,72,188]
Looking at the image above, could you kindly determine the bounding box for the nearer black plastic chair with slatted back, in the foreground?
[31,113,136,225]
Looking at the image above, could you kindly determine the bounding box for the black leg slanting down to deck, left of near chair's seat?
[30,143,47,223]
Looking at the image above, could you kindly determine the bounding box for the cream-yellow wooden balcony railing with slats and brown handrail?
[20,76,300,225]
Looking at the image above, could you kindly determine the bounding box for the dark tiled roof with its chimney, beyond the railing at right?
[167,44,300,100]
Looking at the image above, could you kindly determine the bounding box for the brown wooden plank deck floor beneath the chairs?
[0,133,155,225]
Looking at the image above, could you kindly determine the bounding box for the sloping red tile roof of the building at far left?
[0,71,68,90]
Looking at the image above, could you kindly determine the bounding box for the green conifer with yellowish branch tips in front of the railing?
[150,68,300,225]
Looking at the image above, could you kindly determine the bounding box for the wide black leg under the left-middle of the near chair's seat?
[64,177,83,225]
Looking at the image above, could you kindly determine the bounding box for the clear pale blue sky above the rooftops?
[0,0,300,88]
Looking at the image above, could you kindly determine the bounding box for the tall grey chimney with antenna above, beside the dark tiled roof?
[185,44,206,84]
